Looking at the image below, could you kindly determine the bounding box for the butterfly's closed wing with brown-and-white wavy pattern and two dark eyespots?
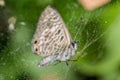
[33,6,71,56]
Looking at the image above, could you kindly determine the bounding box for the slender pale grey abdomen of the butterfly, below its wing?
[38,55,57,67]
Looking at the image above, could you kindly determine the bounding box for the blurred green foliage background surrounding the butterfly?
[0,0,120,80]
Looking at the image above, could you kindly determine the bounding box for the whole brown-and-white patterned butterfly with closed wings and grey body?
[32,6,78,67]
